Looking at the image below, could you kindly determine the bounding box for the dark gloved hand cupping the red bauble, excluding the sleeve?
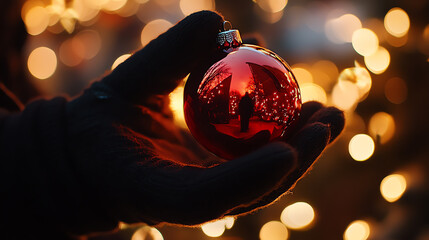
[66,11,344,233]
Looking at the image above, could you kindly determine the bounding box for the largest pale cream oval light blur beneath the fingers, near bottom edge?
[280,202,314,229]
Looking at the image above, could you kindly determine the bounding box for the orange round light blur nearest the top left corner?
[24,6,49,35]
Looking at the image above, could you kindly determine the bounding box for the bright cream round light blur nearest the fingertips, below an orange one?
[349,134,375,161]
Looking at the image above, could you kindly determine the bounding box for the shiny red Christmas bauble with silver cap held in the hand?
[184,23,301,160]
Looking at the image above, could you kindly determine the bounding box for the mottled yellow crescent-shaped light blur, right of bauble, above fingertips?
[338,67,372,99]
